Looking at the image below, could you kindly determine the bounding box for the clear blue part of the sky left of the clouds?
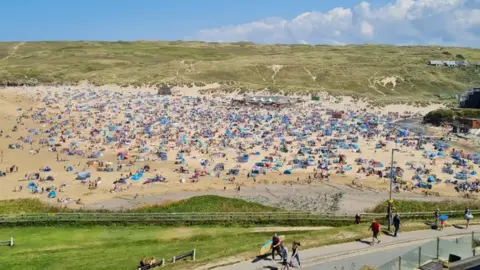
[0,0,388,41]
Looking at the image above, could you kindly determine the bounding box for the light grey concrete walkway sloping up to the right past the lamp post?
[217,225,480,270]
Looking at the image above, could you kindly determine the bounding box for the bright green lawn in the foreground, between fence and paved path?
[0,220,472,270]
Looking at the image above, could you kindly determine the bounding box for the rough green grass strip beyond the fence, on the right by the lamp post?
[368,200,480,213]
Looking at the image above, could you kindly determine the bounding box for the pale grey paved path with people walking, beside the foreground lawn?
[219,226,480,270]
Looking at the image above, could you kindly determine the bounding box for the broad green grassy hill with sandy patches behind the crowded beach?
[0,41,480,100]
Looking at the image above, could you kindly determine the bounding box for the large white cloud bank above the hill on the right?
[197,0,480,47]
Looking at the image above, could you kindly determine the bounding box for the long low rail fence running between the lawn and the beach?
[0,210,474,224]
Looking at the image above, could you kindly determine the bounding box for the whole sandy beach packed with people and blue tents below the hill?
[0,85,480,213]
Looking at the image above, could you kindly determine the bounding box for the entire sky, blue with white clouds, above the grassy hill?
[0,0,480,47]
